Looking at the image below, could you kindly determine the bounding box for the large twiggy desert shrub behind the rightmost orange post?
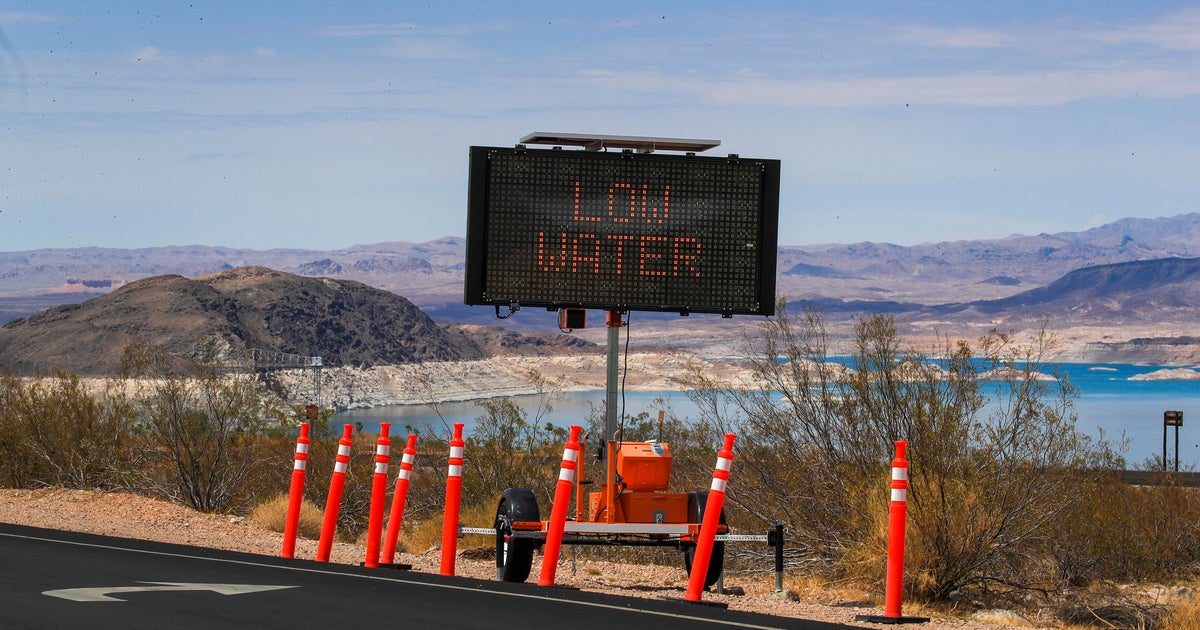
[692,302,1118,600]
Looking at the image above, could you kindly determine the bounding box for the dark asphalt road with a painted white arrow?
[0,523,850,630]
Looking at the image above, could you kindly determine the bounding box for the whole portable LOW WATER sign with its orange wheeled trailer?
[463,132,780,586]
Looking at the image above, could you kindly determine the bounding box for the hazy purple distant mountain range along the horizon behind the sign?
[0,212,1200,361]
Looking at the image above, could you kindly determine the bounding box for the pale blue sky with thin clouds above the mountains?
[0,0,1200,252]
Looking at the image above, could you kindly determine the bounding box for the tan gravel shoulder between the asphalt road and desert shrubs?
[0,488,1032,630]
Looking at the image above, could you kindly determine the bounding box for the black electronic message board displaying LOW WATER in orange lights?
[464,145,779,316]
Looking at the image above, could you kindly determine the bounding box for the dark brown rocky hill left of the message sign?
[0,266,586,373]
